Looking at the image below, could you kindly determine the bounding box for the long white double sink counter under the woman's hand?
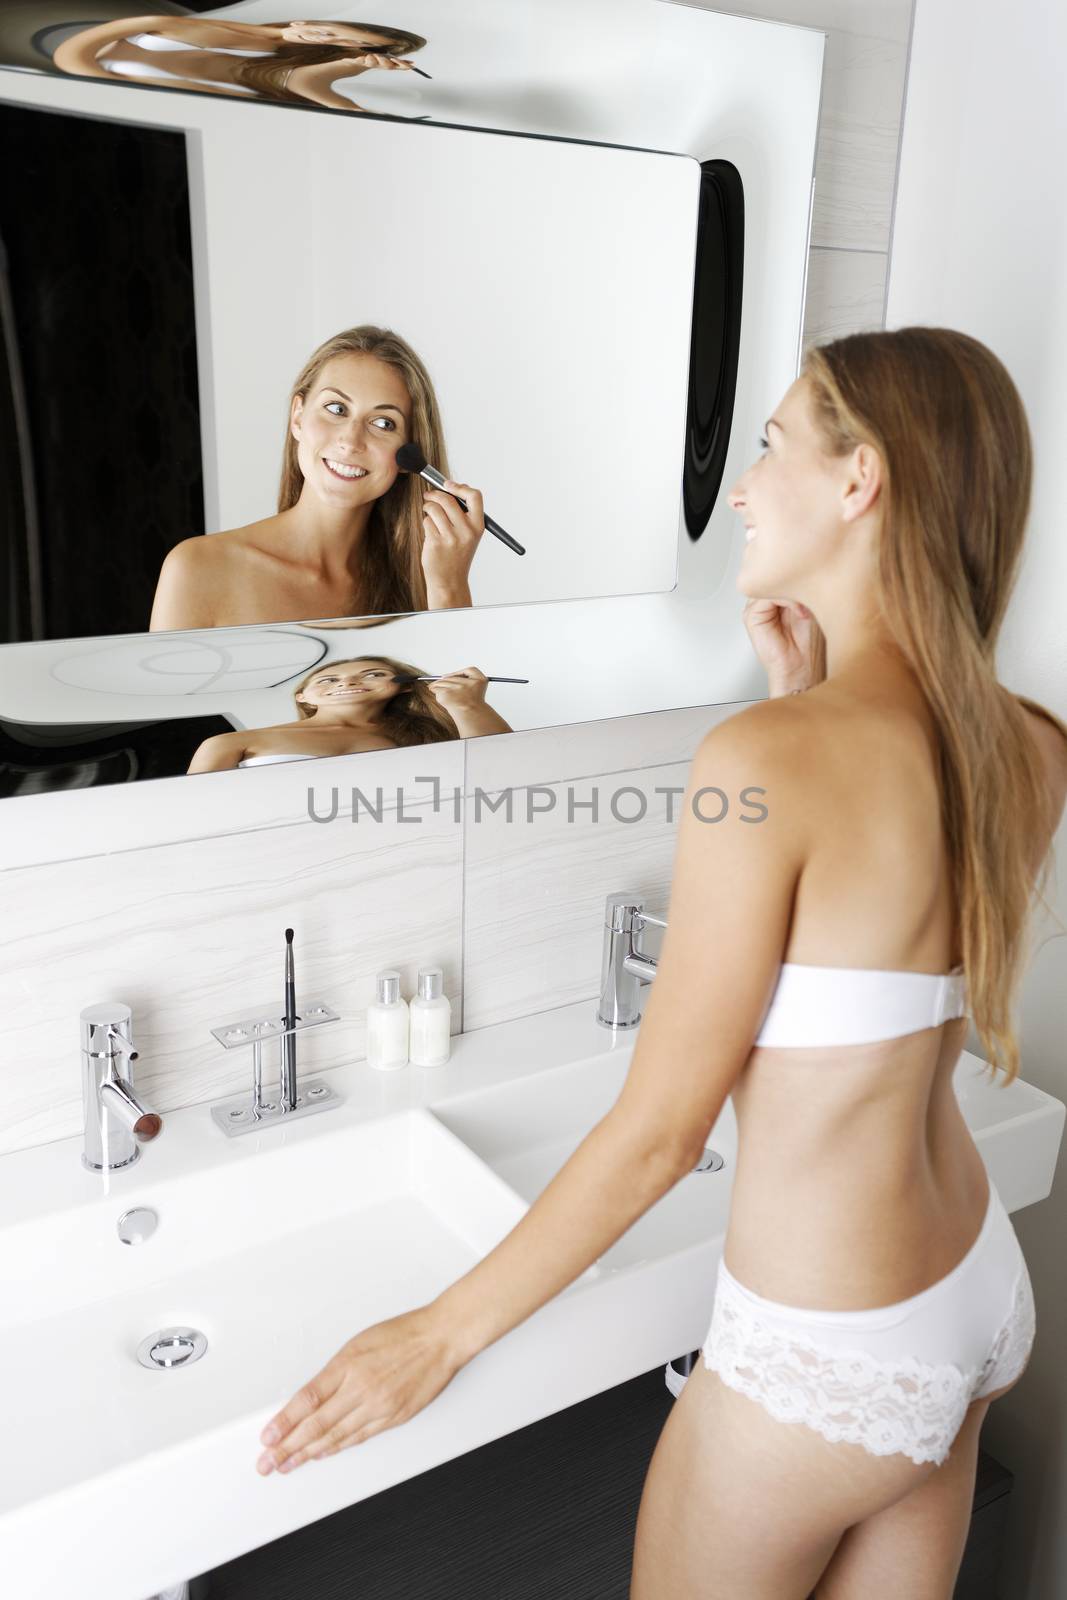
[0,1002,1064,1600]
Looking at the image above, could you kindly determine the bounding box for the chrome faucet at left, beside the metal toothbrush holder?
[82,1000,163,1173]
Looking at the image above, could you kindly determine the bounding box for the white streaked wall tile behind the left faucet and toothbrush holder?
[0,805,462,1160]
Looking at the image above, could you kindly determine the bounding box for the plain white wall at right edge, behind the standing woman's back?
[886,0,1067,1600]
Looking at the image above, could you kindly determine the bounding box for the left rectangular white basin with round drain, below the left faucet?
[0,1109,526,1523]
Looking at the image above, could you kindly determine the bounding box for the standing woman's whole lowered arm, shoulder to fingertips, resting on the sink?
[259,699,813,1472]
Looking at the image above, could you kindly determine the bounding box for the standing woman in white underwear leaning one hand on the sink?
[258,328,1067,1600]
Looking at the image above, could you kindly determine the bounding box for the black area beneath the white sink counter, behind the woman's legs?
[190,1366,1011,1600]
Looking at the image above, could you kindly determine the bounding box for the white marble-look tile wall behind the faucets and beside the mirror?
[0,0,912,1154]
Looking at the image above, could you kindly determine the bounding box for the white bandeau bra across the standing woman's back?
[755,962,966,1045]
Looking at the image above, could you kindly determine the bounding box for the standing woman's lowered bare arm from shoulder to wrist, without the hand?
[434,702,805,1362]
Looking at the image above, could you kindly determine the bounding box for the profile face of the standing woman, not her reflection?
[728,378,848,600]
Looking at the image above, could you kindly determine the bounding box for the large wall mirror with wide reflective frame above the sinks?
[0,9,822,797]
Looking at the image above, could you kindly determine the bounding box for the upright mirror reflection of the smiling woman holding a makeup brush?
[149,325,485,630]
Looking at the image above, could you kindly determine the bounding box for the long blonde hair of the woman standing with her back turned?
[801,328,1067,1083]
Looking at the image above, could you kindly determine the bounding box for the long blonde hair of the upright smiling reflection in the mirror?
[278,323,451,614]
